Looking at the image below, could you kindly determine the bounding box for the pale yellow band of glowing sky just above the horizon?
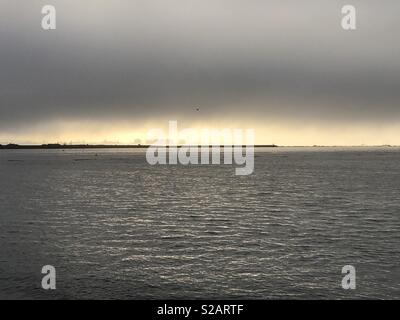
[0,119,400,146]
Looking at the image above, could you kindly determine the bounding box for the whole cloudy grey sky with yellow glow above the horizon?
[0,0,400,145]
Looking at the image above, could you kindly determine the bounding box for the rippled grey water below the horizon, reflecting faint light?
[0,148,400,299]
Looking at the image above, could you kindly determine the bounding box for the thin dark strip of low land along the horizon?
[0,143,278,150]
